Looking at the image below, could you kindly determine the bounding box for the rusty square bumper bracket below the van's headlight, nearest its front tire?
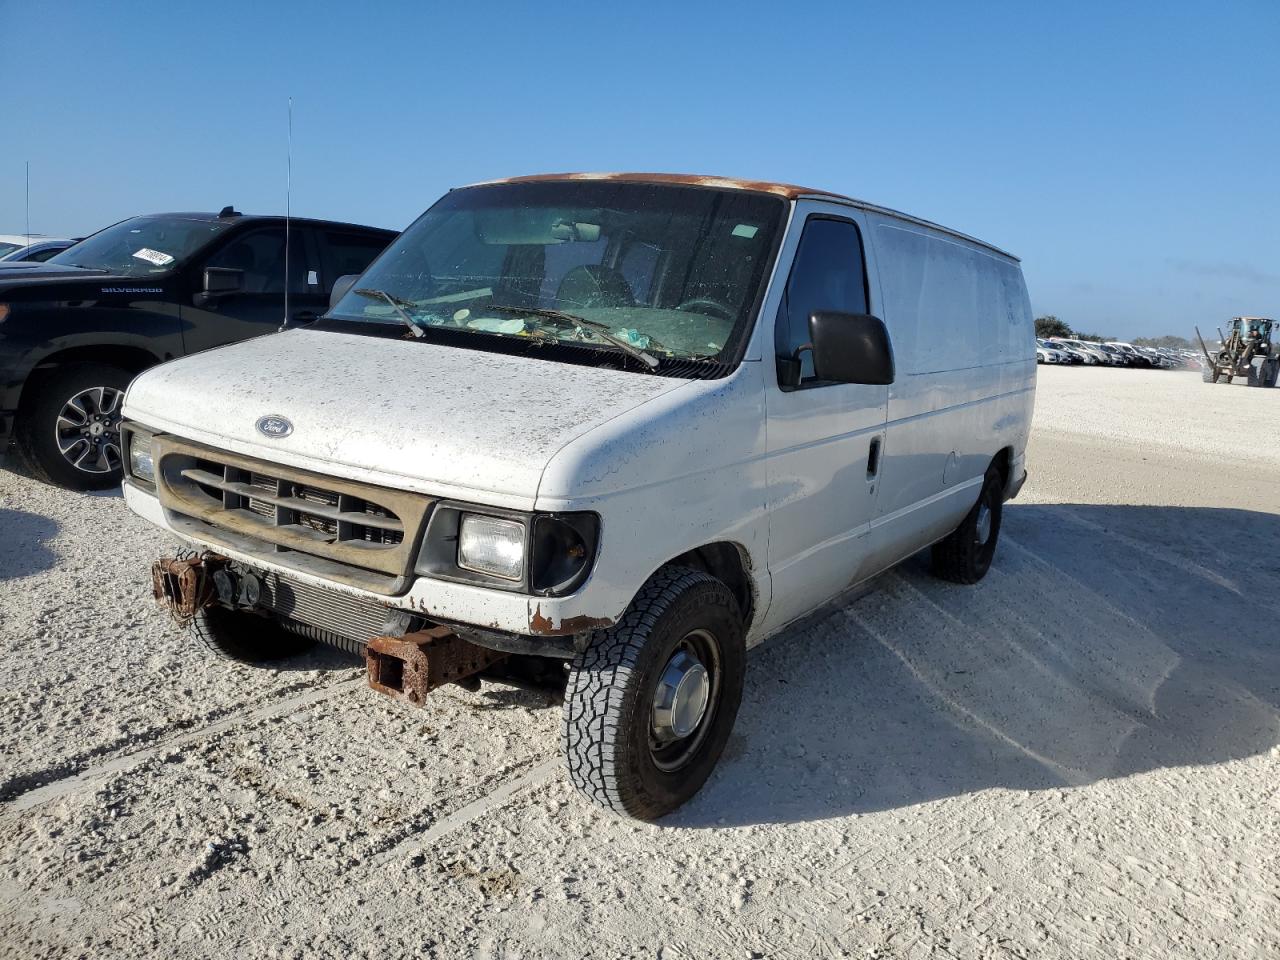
[365,627,507,707]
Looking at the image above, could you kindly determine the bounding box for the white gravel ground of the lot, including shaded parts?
[0,367,1280,960]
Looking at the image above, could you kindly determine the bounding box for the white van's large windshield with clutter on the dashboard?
[329,180,786,362]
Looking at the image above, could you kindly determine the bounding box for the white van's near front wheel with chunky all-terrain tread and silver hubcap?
[561,567,746,820]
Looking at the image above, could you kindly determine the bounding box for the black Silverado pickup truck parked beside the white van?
[0,207,396,490]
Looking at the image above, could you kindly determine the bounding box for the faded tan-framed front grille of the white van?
[154,436,431,593]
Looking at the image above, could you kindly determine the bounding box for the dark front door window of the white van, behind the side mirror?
[773,216,868,383]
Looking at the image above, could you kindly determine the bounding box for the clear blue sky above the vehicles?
[0,0,1280,337]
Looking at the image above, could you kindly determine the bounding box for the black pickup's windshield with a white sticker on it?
[47,216,229,276]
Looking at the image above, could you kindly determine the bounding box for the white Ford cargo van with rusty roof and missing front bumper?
[124,174,1036,818]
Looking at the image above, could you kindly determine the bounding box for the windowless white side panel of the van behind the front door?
[869,214,1036,563]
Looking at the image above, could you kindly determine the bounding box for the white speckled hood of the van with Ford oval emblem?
[124,330,686,506]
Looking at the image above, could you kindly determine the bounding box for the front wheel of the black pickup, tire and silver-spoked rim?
[14,364,133,490]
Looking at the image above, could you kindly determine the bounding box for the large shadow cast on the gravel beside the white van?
[664,503,1280,827]
